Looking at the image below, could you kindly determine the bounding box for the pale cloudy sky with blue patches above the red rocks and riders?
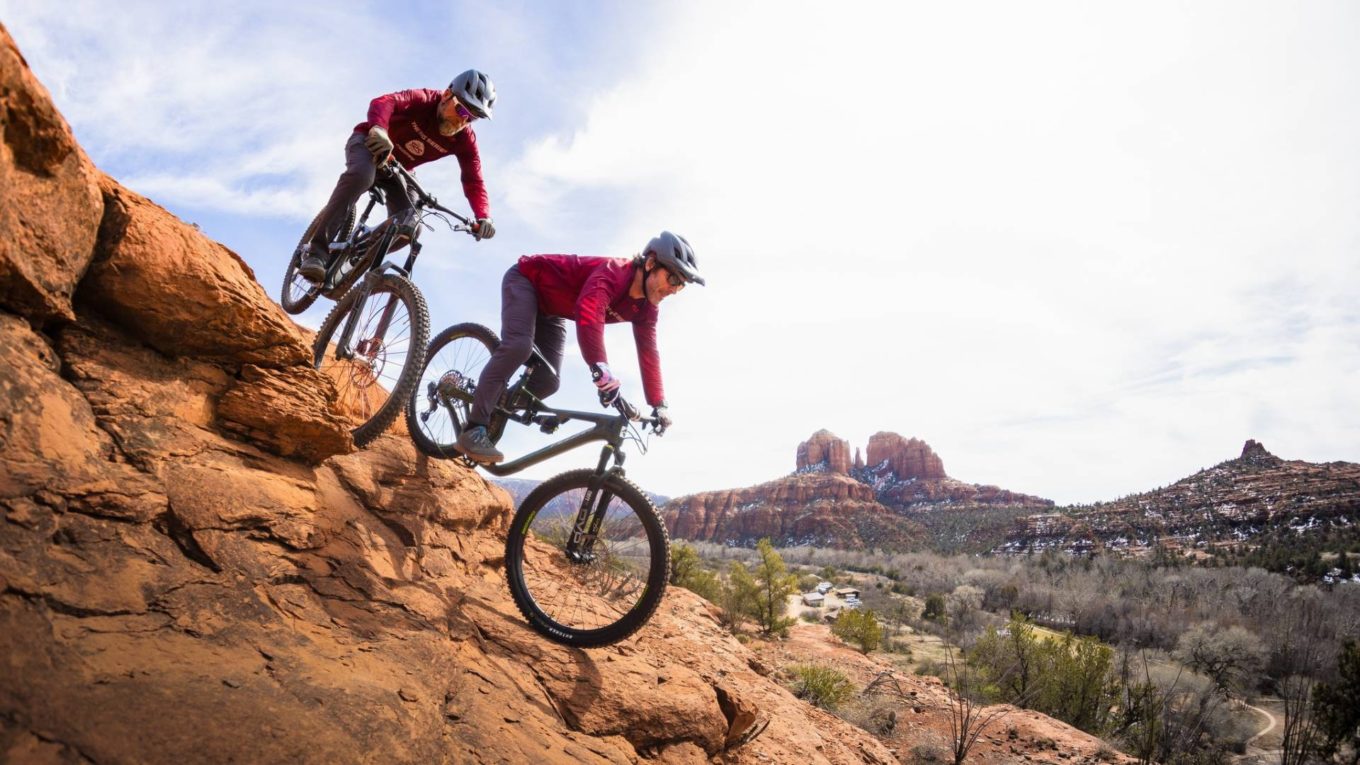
[0,0,1360,504]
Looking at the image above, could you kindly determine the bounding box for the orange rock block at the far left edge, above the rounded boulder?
[0,25,103,325]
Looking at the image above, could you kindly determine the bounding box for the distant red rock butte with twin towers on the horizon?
[664,430,1053,550]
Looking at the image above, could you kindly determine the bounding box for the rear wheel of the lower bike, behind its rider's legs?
[407,323,505,459]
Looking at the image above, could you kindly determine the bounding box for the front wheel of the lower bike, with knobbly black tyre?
[506,470,670,648]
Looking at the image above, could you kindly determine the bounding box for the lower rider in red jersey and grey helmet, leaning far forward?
[457,231,704,463]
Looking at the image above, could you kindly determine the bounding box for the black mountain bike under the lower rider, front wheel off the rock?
[407,324,670,648]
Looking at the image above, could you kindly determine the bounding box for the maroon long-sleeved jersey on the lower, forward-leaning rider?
[520,255,665,406]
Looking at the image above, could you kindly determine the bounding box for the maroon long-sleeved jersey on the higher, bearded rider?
[354,88,491,218]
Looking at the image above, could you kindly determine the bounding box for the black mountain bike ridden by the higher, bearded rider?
[279,162,472,446]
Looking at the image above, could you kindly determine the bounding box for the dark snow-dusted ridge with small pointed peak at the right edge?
[996,441,1360,555]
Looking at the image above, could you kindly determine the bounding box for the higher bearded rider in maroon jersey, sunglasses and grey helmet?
[298,69,496,282]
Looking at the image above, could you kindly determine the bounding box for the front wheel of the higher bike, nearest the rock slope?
[311,274,430,446]
